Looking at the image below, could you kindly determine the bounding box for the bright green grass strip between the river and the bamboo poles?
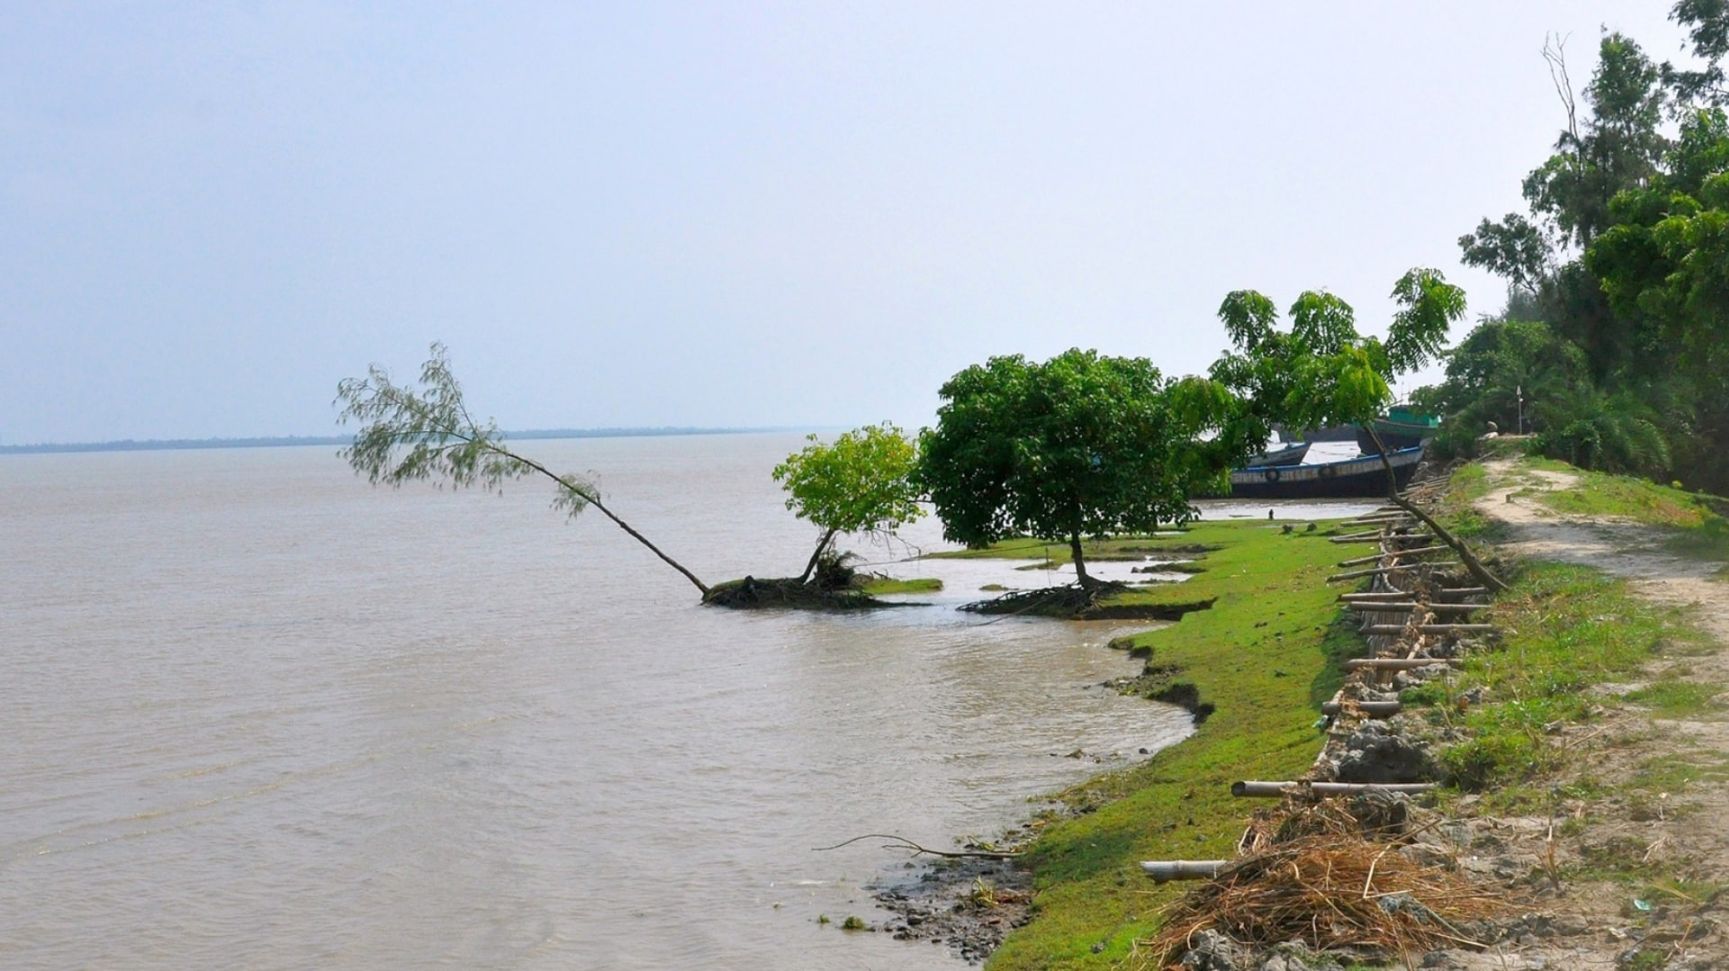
[972,522,1356,969]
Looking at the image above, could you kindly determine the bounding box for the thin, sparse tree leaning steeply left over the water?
[335,344,709,596]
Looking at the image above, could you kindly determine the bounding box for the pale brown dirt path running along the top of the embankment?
[1425,461,1729,971]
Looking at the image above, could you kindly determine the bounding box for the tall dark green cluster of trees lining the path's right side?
[1425,10,1729,489]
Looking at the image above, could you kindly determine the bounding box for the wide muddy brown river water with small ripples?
[0,434,1376,969]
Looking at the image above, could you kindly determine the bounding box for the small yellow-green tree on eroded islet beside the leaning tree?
[775,422,923,582]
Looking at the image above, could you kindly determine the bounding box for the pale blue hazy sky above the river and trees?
[0,0,1681,444]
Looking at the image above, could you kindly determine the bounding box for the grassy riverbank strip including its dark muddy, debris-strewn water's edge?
[919,520,1349,971]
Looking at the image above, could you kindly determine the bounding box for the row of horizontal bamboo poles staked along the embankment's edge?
[1141,475,1494,883]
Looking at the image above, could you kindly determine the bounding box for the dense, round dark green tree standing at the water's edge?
[916,349,1219,591]
